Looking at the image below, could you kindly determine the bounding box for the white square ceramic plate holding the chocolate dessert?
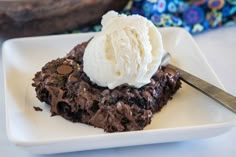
[3,28,236,154]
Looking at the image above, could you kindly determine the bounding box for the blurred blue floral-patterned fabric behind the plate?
[74,0,236,34]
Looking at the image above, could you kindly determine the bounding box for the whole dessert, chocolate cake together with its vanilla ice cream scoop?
[32,11,181,132]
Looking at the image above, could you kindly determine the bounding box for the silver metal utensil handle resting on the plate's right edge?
[168,64,236,113]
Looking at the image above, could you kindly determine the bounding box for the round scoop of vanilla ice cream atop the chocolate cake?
[83,11,164,89]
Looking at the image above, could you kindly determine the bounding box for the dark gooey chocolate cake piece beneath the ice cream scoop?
[32,42,181,132]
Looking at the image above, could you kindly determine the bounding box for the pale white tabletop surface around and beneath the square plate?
[0,26,236,157]
